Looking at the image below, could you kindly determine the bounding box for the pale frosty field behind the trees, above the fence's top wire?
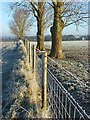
[32,41,89,81]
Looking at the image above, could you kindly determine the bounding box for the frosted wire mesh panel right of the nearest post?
[47,69,89,120]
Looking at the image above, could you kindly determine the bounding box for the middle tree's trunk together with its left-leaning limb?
[30,2,45,50]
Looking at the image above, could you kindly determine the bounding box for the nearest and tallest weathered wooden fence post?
[42,51,47,110]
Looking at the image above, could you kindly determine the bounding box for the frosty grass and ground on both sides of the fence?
[0,41,90,119]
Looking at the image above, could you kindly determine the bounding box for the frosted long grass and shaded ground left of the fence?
[2,42,50,119]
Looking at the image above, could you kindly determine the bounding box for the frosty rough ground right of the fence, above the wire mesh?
[46,41,90,115]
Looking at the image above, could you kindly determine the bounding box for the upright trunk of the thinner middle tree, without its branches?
[37,2,44,50]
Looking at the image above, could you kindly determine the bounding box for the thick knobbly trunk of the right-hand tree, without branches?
[50,2,64,59]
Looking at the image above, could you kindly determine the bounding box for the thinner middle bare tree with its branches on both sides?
[30,0,52,50]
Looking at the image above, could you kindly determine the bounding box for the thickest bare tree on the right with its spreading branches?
[49,0,87,58]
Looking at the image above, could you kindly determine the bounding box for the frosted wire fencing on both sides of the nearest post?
[23,39,90,120]
